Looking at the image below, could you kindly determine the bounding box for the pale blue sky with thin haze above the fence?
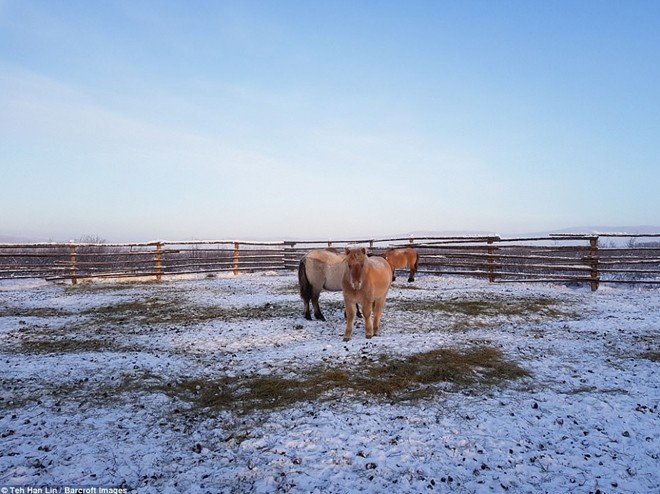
[0,0,660,241]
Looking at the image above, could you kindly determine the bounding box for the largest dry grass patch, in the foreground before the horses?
[154,347,529,413]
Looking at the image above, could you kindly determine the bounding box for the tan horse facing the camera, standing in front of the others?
[342,248,392,341]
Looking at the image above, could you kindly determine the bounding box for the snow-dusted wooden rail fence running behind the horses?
[0,233,660,290]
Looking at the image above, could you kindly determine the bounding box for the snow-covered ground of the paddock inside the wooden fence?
[0,273,660,493]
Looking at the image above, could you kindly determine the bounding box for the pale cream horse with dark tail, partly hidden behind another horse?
[298,249,358,321]
